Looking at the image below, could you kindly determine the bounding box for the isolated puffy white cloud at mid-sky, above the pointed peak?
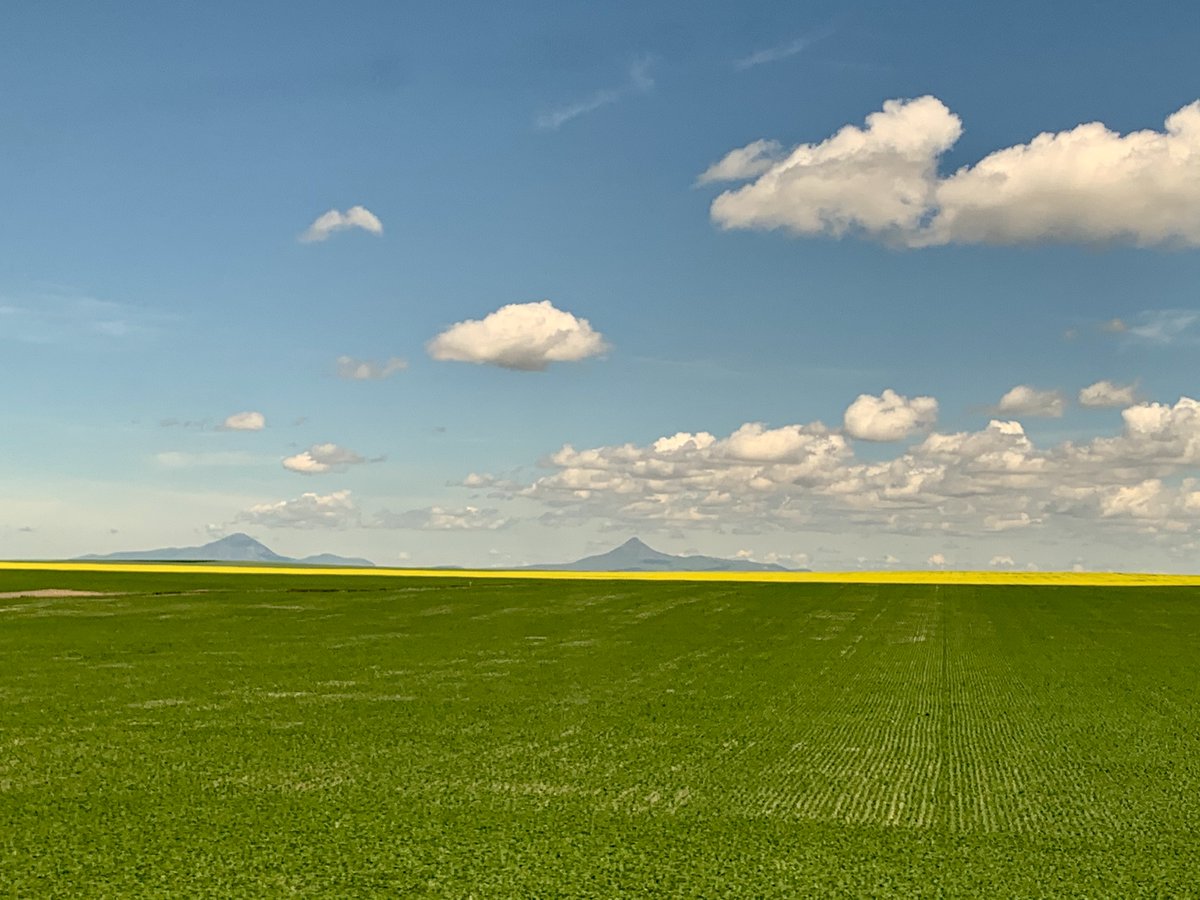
[426,300,608,372]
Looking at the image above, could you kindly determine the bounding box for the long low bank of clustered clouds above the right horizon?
[461,397,1200,559]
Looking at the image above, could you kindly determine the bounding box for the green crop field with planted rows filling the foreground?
[0,571,1200,898]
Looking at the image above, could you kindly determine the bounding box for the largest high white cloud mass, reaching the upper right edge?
[712,96,1200,247]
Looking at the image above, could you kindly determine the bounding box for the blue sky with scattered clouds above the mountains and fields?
[0,1,1200,571]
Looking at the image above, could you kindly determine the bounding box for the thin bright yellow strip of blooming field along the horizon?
[0,562,1200,587]
